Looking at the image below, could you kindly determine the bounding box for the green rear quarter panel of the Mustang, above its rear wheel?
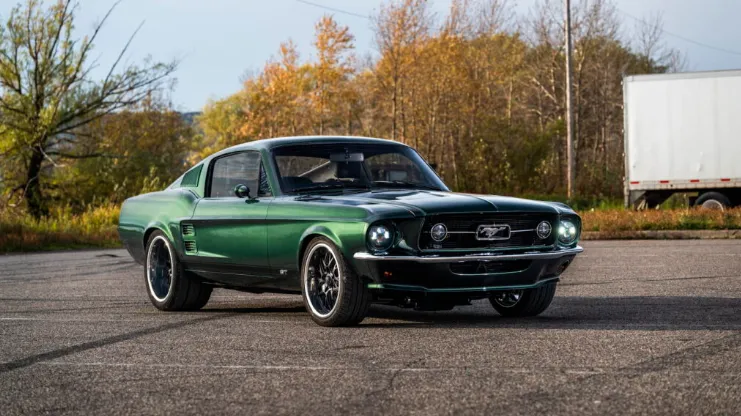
[118,188,198,264]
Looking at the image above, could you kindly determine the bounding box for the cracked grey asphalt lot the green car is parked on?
[0,240,741,415]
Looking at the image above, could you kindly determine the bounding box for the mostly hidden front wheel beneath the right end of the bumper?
[489,282,556,317]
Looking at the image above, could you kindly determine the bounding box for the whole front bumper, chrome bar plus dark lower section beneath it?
[353,246,584,294]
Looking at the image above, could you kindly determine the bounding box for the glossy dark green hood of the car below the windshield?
[310,189,573,217]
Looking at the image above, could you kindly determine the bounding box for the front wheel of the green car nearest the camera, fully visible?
[301,237,371,326]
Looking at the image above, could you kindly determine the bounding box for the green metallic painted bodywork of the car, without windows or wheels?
[119,137,578,290]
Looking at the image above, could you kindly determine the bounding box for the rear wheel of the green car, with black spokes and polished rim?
[144,231,212,311]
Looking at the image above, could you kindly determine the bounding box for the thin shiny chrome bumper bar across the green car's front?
[353,246,584,263]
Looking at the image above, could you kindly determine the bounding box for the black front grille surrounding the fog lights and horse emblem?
[419,213,557,250]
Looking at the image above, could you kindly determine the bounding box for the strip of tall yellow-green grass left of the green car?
[0,205,121,253]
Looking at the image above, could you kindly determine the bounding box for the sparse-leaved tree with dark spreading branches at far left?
[0,0,176,217]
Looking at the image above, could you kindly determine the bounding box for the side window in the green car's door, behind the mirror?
[208,152,270,198]
